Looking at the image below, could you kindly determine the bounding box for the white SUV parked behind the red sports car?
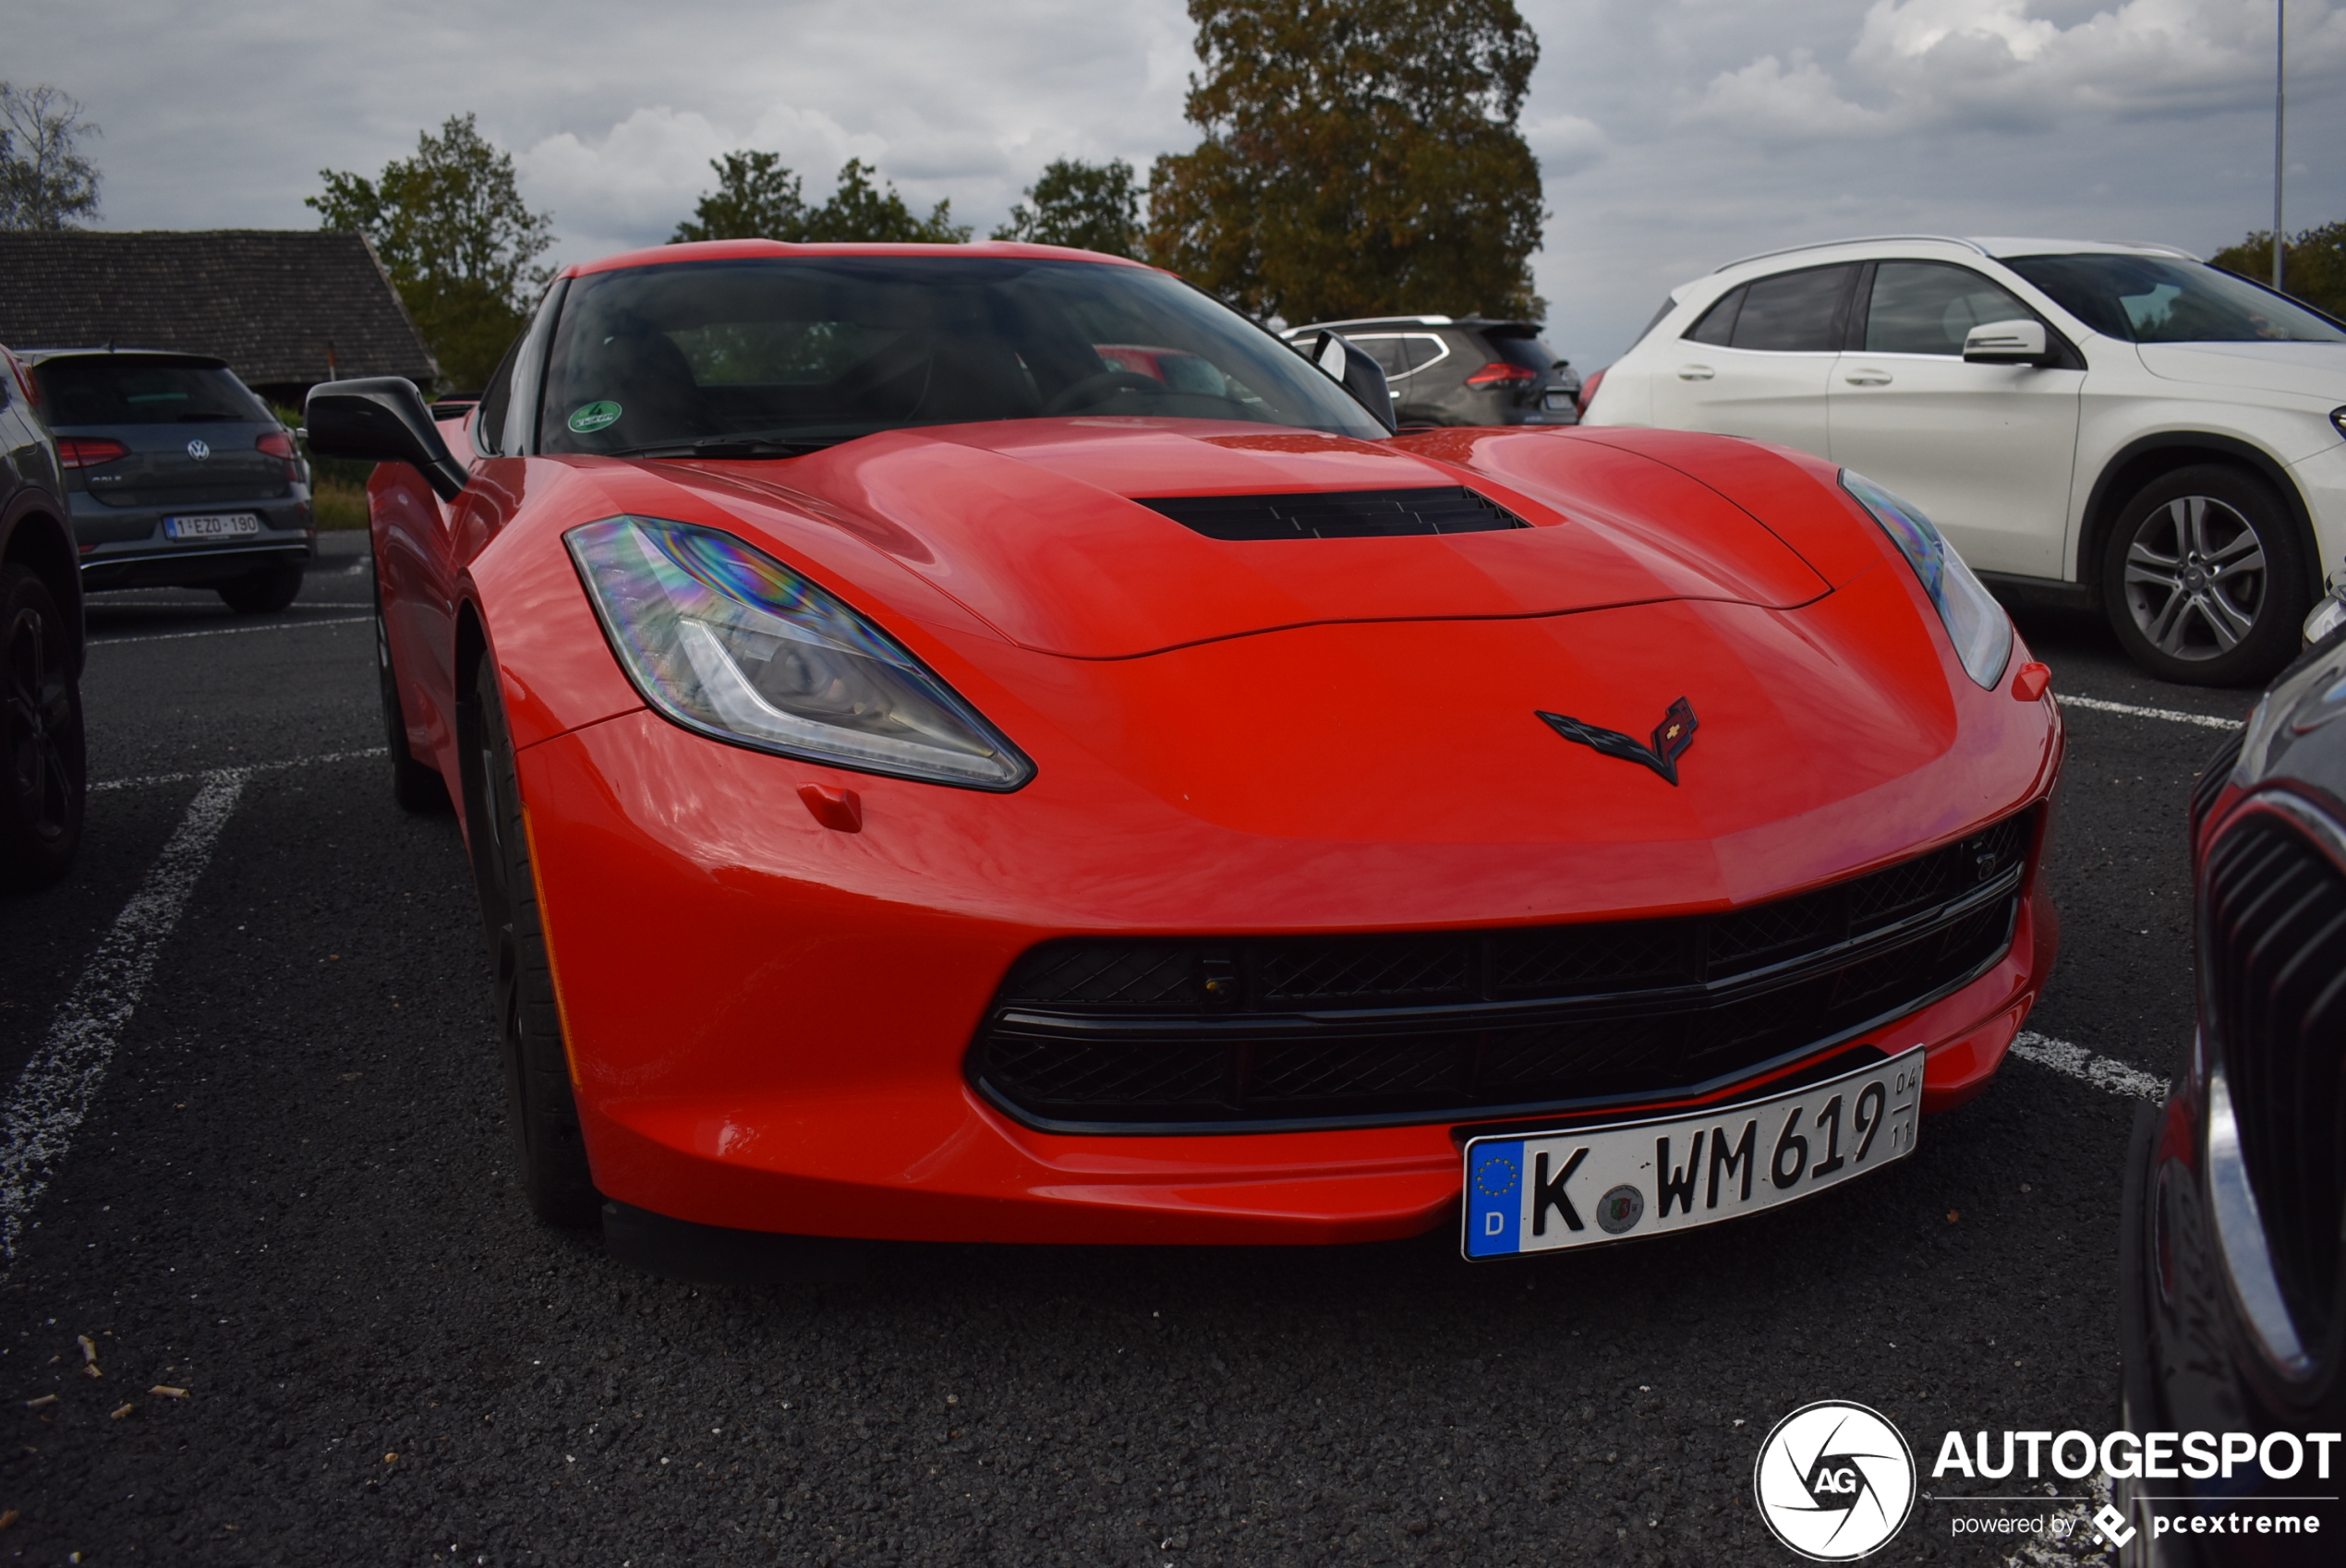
[1581,236,2346,684]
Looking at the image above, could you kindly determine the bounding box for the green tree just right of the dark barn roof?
[305,115,553,389]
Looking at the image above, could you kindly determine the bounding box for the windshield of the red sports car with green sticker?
[539,253,1385,457]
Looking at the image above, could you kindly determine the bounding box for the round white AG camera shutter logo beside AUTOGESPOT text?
[1752,1399,1915,1563]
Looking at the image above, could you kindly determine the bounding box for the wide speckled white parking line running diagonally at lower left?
[0,769,248,1272]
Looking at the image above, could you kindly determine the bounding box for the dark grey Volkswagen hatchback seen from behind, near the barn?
[23,349,317,614]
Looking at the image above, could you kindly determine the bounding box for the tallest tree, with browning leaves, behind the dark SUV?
[1147,0,1546,321]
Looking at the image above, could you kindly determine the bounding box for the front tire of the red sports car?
[460,657,603,1228]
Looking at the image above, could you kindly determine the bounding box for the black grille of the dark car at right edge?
[2203,811,2346,1345]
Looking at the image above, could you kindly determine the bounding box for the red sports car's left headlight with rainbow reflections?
[565,518,1034,790]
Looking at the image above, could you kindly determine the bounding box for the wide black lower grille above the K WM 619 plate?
[969,814,2034,1132]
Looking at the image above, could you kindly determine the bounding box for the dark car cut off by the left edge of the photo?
[0,349,87,890]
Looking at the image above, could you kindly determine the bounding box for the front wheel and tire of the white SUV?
[2102,464,2313,687]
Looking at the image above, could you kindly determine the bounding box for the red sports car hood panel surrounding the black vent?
[659,419,1828,658]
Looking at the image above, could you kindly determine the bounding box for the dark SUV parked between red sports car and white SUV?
[1283,317,1581,428]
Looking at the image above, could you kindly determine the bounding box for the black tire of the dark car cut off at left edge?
[0,567,90,890]
